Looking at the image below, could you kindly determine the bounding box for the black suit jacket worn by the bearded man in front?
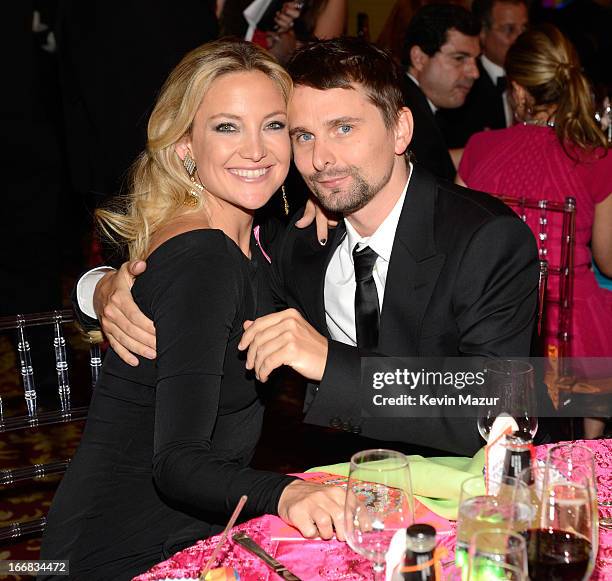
[273,164,538,454]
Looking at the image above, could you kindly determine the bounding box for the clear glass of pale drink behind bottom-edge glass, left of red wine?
[455,476,516,576]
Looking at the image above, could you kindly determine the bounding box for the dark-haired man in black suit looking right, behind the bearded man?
[403,4,480,181]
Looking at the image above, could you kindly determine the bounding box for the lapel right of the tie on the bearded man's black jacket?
[378,165,446,356]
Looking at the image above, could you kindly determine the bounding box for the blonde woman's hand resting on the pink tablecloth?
[278,480,346,541]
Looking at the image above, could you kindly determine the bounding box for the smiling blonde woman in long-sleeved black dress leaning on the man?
[41,41,343,581]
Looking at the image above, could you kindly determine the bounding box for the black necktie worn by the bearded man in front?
[353,246,380,349]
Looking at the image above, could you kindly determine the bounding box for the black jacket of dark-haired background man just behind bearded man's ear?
[402,75,457,181]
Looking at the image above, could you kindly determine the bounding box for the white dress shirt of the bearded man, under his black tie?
[325,172,412,345]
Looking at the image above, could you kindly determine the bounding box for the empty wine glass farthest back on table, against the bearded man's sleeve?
[478,359,538,442]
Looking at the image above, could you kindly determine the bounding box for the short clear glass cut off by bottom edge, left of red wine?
[468,528,527,580]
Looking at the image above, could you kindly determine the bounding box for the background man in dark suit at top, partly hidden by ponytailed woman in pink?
[441,0,529,148]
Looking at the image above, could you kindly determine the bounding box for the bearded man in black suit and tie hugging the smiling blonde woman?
[83,39,538,454]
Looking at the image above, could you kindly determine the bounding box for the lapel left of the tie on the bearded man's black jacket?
[290,220,346,337]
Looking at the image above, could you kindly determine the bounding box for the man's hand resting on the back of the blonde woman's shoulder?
[93,260,157,366]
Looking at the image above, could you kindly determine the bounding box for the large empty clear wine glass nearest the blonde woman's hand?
[344,449,414,580]
